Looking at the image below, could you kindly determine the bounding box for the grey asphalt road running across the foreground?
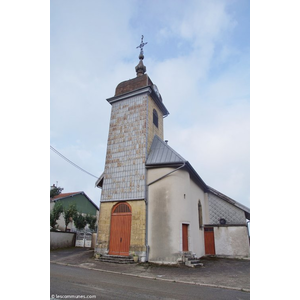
[50,263,250,300]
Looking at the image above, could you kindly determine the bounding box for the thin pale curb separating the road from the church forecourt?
[50,261,250,293]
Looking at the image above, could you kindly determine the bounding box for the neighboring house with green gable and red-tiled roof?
[50,192,99,232]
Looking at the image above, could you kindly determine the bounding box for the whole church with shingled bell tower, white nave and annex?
[95,37,250,264]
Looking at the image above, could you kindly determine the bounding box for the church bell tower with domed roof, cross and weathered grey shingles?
[96,37,169,257]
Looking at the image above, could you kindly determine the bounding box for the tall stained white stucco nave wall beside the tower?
[148,168,208,262]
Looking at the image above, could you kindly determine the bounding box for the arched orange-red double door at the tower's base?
[109,202,131,256]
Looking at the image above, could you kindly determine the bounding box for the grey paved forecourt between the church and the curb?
[50,248,250,292]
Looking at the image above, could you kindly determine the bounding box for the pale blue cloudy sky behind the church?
[49,0,250,207]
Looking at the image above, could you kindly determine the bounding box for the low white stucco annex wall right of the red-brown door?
[214,226,250,257]
